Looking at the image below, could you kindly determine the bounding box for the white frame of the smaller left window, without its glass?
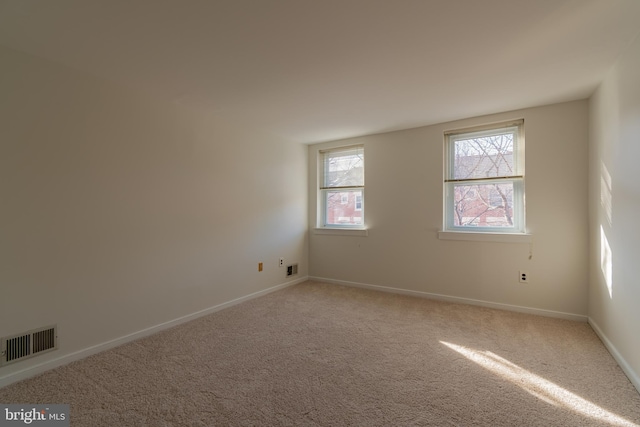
[318,145,365,230]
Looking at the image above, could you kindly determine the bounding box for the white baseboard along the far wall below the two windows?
[309,277,588,322]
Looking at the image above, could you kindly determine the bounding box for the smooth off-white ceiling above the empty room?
[0,0,640,143]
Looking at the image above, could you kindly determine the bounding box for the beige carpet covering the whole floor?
[0,282,640,426]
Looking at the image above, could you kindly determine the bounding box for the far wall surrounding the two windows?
[309,100,589,320]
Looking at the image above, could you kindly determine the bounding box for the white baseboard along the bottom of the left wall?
[0,276,309,388]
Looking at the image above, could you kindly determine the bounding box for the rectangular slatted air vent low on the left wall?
[0,325,58,366]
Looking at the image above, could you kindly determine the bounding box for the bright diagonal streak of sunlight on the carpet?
[440,341,636,426]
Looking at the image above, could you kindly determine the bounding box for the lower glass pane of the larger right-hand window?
[453,182,514,227]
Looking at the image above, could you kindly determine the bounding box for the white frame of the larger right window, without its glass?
[443,120,526,234]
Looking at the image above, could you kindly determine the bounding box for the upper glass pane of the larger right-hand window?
[452,131,516,179]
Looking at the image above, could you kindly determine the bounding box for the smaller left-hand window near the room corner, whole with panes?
[320,146,364,228]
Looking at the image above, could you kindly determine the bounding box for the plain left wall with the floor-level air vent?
[0,48,308,385]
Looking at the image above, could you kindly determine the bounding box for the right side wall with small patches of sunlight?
[589,32,640,390]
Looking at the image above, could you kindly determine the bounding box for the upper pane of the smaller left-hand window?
[324,147,364,187]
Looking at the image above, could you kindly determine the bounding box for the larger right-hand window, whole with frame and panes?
[444,121,525,233]
